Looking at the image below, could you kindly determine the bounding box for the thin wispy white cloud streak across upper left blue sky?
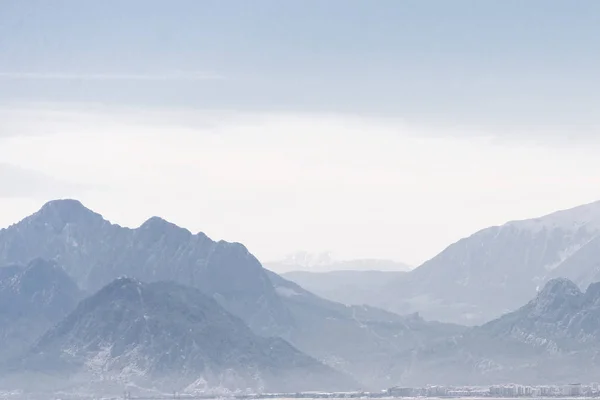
[0,71,224,81]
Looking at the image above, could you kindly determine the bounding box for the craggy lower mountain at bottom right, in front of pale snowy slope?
[405,278,600,385]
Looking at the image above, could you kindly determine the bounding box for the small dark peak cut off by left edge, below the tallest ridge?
[0,259,82,361]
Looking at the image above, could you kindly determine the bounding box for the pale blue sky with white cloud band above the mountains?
[0,0,600,265]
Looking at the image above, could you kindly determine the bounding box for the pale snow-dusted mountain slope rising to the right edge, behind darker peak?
[376,202,600,325]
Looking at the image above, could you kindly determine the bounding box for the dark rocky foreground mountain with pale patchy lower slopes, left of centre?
[13,278,353,392]
